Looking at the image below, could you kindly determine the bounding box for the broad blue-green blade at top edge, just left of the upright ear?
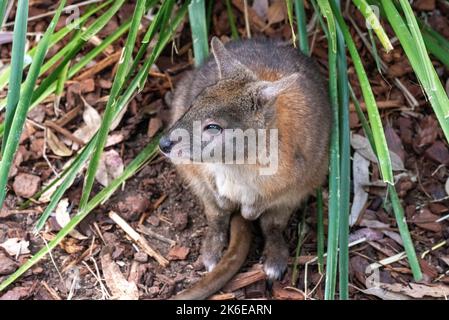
[189,0,209,66]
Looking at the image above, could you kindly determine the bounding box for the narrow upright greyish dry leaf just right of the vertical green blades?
[349,151,370,227]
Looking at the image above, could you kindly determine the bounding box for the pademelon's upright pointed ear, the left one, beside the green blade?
[210,37,255,79]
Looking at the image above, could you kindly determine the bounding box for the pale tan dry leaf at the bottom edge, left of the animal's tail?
[100,247,139,300]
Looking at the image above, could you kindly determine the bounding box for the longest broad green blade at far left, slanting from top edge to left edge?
[0,0,66,207]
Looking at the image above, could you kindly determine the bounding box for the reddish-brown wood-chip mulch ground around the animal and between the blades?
[0,1,449,299]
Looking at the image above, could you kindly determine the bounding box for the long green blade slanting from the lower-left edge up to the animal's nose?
[0,137,158,292]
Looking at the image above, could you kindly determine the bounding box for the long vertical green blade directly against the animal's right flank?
[318,0,341,300]
